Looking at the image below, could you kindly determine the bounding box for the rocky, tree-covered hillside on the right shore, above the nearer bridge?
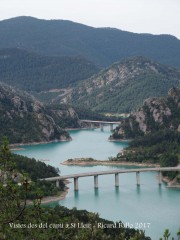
[110,88,180,179]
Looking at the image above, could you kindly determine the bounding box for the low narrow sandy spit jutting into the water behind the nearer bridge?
[60,160,160,167]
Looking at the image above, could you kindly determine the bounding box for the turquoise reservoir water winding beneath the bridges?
[16,126,180,240]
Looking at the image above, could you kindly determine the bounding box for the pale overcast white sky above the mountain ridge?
[0,0,180,39]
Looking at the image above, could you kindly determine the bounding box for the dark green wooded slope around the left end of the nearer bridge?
[12,154,65,200]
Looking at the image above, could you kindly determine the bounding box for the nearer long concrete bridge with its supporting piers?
[40,167,180,190]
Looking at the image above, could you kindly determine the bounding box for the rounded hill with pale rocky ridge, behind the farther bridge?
[57,57,180,112]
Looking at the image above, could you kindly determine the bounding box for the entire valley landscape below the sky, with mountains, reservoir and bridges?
[0,16,180,240]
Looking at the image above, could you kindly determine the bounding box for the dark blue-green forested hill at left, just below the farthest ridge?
[0,48,99,92]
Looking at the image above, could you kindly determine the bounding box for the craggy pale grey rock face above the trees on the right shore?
[112,88,180,138]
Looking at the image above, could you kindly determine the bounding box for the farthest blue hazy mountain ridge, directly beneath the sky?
[0,17,180,66]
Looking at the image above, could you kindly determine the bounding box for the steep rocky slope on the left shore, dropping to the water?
[0,84,70,143]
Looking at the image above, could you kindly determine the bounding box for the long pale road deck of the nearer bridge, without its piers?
[41,167,180,181]
